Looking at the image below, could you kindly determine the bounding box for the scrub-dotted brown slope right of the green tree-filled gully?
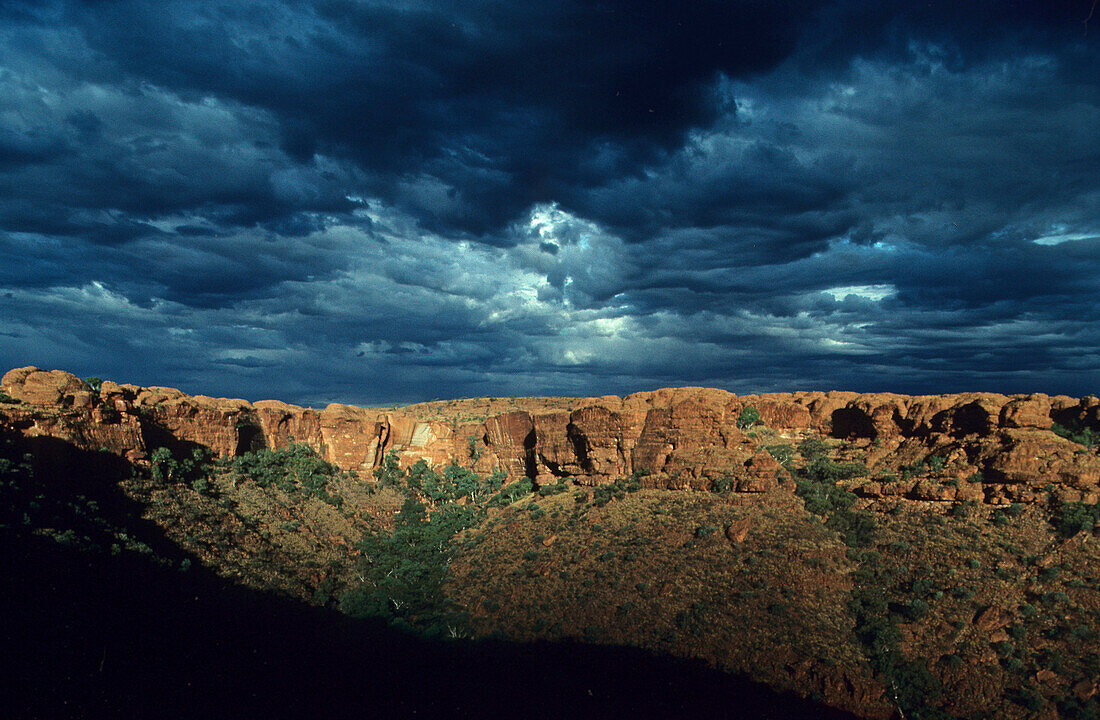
[435,443,1100,719]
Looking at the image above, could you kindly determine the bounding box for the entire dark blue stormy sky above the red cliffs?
[0,0,1100,406]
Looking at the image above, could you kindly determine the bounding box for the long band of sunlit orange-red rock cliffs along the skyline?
[0,367,1100,503]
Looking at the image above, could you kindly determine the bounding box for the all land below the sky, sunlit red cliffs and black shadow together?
[0,368,1100,720]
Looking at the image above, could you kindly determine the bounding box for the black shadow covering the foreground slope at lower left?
[0,430,850,720]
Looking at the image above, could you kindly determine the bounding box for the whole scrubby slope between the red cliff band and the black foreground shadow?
[0,404,1100,719]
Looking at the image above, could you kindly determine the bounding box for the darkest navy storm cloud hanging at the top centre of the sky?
[40,1,809,234]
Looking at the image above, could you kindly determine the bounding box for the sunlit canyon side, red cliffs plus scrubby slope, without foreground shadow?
[0,367,1100,719]
